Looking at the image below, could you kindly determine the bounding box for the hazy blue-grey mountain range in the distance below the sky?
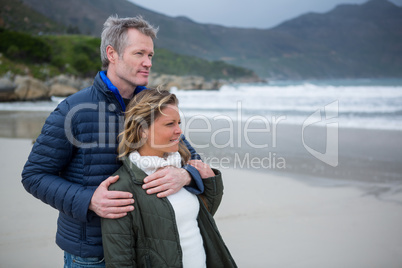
[13,0,402,79]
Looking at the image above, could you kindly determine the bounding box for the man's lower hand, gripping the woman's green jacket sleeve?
[89,176,134,219]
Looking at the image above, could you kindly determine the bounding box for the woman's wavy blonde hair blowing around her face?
[119,89,191,164]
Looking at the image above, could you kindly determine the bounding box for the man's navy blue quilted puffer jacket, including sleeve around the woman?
[22,73,203,257]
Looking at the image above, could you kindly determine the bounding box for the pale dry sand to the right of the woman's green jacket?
[215,170,402,268]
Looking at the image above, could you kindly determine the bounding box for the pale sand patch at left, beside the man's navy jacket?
[0,138,63,268]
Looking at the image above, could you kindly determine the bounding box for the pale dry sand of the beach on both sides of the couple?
[0,138,402,268]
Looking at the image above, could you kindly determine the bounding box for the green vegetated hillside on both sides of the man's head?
[0,29,255,80]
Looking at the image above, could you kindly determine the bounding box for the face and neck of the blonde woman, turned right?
[138,105,182,157]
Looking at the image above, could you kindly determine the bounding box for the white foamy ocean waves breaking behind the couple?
[0,79,402,130]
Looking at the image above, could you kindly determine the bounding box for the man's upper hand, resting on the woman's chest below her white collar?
[142,166,191,198]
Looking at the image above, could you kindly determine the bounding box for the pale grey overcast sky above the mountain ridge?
[129,0,402,28]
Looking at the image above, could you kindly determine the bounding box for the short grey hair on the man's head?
[100,16,158,70]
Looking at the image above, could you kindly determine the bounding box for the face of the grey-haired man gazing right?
[115,29,154,88]
